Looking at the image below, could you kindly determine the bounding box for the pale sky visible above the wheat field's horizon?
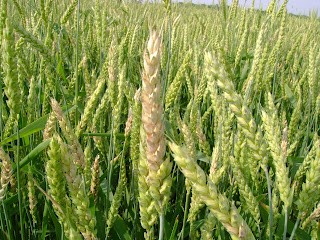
[180,0,320,16]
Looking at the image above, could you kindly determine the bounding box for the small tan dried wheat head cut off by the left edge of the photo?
[0,147,12,202]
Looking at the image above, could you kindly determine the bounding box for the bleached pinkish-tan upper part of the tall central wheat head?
[141,31,165,172]
